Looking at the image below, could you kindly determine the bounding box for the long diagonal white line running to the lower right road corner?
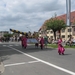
[8,46,75,75]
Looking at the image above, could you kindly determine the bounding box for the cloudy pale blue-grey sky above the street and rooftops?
[0,0,75,32]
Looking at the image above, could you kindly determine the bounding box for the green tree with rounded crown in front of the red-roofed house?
[46,17,66,40]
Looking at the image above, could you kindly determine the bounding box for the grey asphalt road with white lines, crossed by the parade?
[0,43,75,75]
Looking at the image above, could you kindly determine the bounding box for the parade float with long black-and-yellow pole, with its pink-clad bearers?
[10,29,48,49]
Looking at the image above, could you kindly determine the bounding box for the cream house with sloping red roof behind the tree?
[39,11,75,40]
